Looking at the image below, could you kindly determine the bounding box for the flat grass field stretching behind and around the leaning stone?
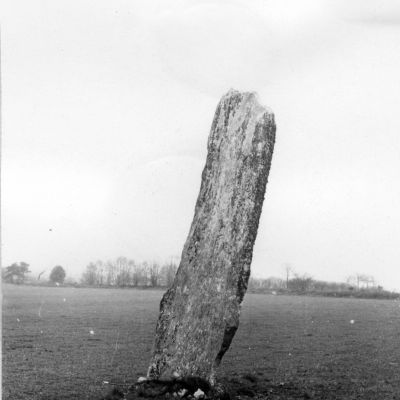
[2,285,400,400]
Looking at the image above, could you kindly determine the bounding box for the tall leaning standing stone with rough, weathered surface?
[148,90,276,384]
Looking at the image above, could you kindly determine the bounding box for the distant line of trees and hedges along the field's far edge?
[2,257,399,298]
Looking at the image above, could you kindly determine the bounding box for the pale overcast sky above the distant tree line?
[1,0,400,290]
